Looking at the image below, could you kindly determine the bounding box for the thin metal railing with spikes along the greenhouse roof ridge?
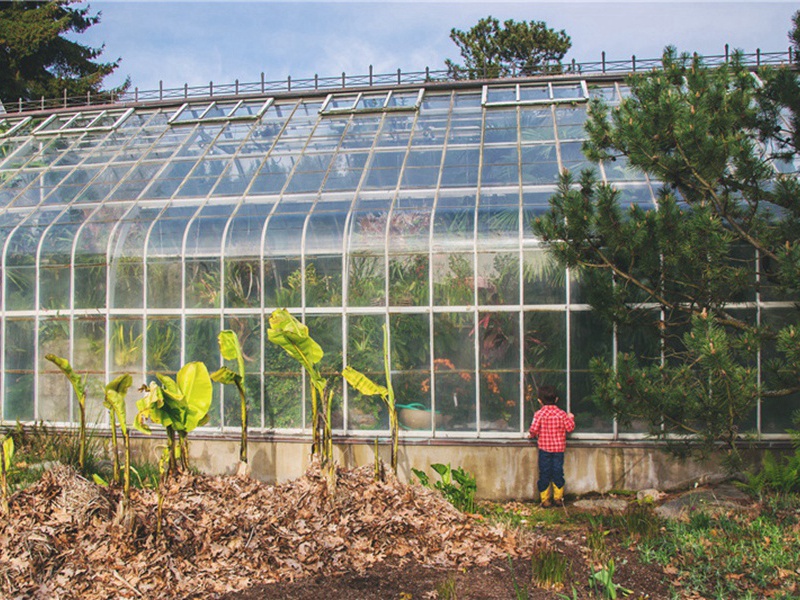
[5,44,797,115]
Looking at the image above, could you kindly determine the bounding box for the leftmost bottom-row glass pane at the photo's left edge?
[3,319,35,423]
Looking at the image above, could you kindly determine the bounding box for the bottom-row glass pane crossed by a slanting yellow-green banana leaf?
[347,315,389,429]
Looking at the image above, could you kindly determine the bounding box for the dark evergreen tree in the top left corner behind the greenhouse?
[0,0,128,103]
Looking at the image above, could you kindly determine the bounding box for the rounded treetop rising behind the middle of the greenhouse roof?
[445,16,572,79]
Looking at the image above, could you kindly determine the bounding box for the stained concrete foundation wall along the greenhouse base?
[130,438,723,500]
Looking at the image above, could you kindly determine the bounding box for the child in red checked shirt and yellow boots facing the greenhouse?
[528,385,575,508]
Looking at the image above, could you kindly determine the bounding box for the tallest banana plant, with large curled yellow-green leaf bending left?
[267,308,333,465]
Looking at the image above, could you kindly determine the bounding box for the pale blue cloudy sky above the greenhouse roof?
[72,0,800,90]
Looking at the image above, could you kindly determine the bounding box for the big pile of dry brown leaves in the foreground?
[0,464,536,599]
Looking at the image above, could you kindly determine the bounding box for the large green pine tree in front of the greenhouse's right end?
[534,38,800,467]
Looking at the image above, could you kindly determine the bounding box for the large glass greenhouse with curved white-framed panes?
[0,68,791,494]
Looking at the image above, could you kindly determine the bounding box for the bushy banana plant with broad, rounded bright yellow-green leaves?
[133,362,213,473]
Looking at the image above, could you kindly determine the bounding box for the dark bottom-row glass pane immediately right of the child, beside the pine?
[570,311,613,433]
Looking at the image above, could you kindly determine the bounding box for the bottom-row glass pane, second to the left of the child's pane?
[433,313,477,431]
